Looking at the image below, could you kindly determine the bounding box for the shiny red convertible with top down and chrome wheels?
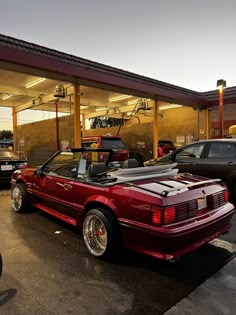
[11,148,234,260]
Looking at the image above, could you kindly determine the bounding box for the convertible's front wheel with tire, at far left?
[11,183,30,213]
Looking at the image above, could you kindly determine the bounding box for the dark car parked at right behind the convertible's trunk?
[148,138,236,197]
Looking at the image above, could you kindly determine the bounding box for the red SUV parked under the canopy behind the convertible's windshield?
[82,134,129,165]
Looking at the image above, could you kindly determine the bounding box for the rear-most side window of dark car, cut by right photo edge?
[208,142,236,159]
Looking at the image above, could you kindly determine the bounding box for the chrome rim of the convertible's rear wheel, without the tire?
[83,213,108,256]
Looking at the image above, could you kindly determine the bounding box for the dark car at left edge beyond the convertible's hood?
[0,149,28,184]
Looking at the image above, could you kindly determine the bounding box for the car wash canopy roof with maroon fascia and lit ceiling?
[0,34,236,123]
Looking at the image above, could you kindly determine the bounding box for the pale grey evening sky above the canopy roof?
[0,0,236,129]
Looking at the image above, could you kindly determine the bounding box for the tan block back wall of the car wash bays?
[14,107,206,165]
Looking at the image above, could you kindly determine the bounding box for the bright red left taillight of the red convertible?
[151,206,176,225]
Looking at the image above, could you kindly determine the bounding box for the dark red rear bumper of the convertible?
[122,203,235,260]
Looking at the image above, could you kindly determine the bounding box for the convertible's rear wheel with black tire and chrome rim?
[83,208,121,259]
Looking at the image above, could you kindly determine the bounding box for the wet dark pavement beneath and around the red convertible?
[0,190,236,315]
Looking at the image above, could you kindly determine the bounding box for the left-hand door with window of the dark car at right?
[172,142,205,176]
